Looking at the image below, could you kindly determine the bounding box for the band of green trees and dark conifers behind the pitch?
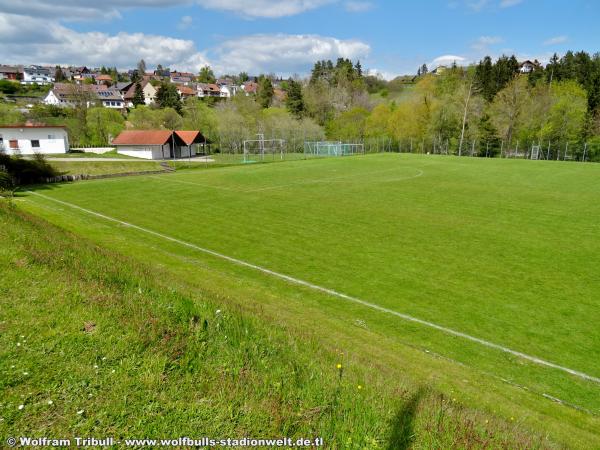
[0,51,600,161]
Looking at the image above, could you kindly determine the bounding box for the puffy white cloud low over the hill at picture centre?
[214,34,370,75]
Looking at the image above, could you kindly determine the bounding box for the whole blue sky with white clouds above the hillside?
[0,0,600,78]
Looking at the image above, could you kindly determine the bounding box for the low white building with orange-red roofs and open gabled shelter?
[111,130,206,159]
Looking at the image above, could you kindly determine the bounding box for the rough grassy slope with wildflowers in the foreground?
[0,204,551,448]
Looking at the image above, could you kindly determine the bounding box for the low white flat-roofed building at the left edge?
[0,124,69,155]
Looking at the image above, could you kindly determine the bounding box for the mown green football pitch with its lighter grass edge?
[9,154,600,447]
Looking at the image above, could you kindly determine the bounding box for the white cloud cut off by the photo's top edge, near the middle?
[196,0,335,18]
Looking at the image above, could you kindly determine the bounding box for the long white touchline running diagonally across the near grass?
[26,191,600,384]
